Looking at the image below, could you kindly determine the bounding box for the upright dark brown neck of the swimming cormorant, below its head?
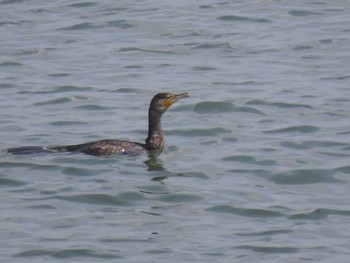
[146,109,164,150]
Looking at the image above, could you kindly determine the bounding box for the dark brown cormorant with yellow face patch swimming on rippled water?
[6,93,189,156]
